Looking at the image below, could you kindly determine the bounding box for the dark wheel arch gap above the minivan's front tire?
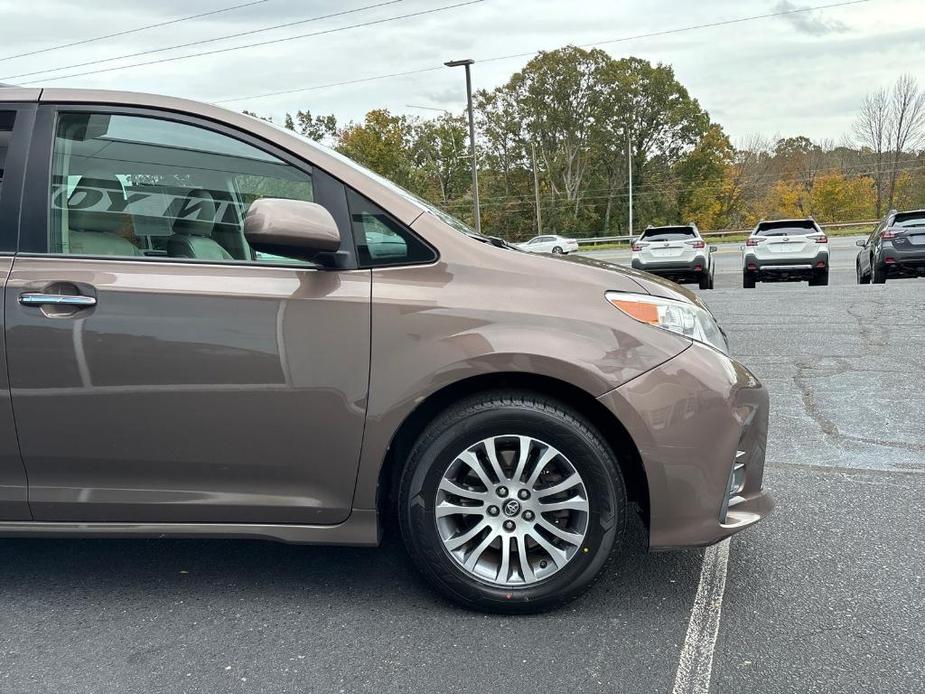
[376,372,650,529]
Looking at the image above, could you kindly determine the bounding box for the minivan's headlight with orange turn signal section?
[604,292,729,354]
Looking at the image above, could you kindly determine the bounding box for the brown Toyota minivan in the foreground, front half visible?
[0,88,772,612]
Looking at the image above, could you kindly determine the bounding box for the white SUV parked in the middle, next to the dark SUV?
[742,218,829,289]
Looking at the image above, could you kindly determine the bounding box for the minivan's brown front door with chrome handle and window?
[6,109,371,524]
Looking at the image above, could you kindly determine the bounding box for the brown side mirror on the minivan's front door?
[244,198,340,260]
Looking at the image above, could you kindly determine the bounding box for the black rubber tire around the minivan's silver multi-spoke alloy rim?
[398,391,627,614]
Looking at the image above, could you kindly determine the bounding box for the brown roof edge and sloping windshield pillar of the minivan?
[0,86,427,224]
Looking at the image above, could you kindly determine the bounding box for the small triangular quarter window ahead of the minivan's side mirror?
[347,189,436,267]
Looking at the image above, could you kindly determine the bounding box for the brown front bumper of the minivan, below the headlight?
[599,342,774,550]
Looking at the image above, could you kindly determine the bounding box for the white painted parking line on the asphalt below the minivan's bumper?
[671,539,729,694]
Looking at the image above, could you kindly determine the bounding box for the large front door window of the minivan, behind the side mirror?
[48,113,314,262]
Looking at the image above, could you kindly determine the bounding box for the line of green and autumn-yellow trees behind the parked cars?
[245,46,925,240]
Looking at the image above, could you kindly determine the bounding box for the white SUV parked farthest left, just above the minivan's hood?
[631,224,716,289]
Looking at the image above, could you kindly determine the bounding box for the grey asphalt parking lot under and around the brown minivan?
[0,240,925,694]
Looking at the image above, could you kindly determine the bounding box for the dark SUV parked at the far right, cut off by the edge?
[856,210,925,284]
